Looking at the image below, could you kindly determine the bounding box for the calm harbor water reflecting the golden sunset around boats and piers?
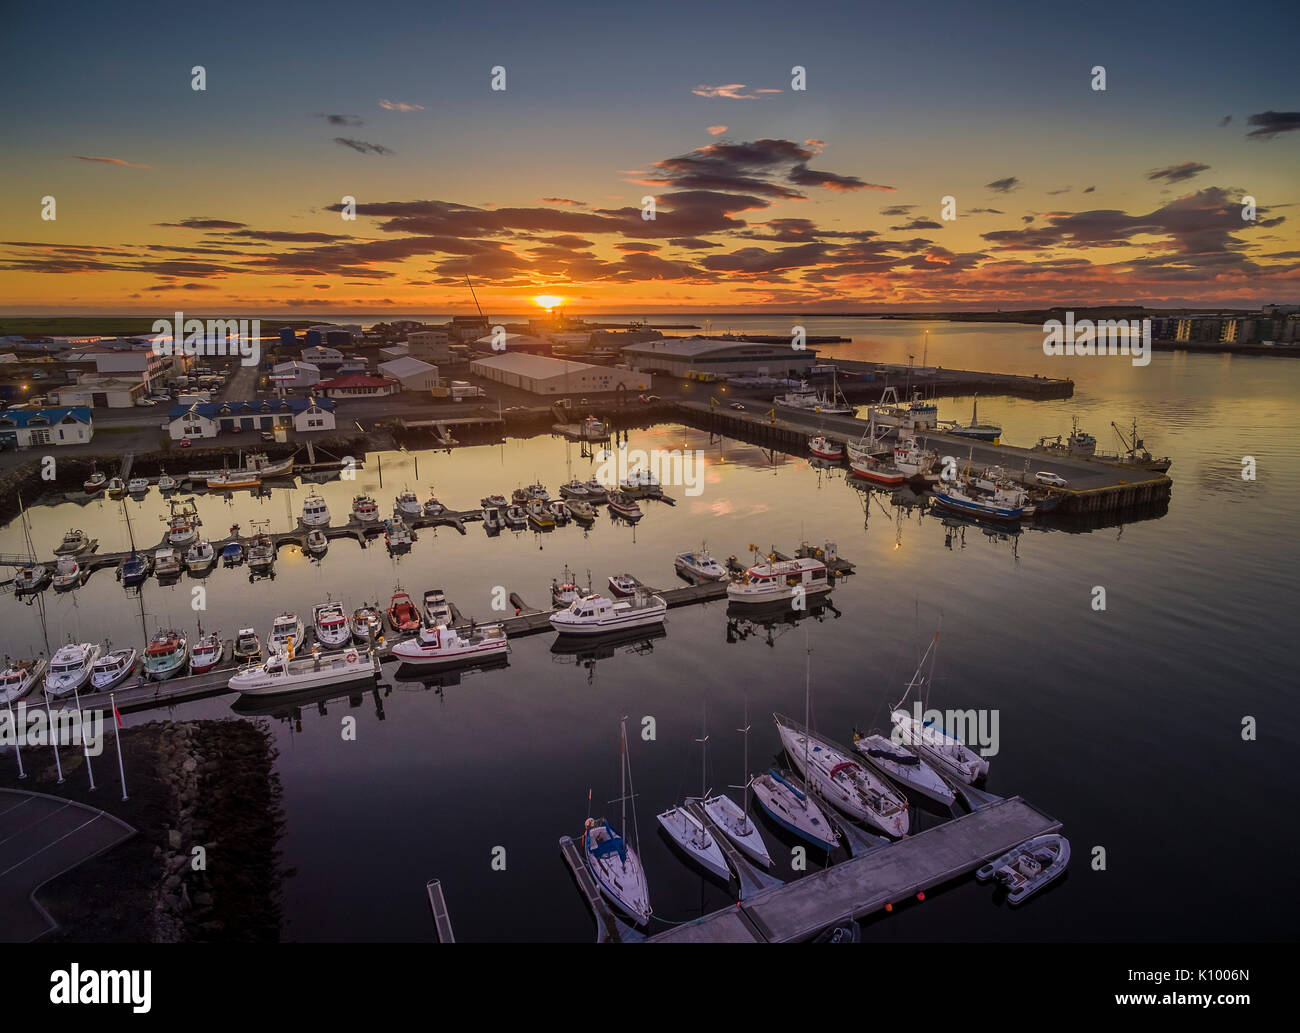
[0,317,1300,941]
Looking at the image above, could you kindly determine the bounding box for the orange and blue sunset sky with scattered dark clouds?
[0,0,1300,317]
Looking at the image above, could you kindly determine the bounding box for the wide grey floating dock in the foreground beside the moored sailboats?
[647,797,1061,943]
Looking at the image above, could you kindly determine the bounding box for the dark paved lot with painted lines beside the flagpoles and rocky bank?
[0,789,135,943]
